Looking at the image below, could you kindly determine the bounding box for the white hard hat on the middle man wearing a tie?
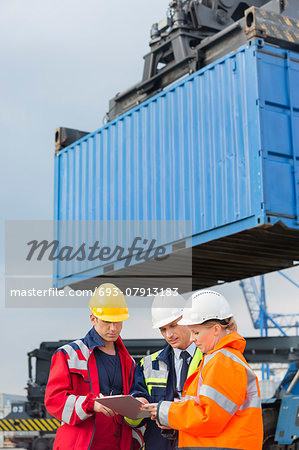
[152,291,186,328]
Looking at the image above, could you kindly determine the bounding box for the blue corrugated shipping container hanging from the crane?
[54,40,299,288]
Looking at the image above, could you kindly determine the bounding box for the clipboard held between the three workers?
[95,395,151,420]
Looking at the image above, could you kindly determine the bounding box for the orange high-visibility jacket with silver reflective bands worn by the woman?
[157,332,263,450]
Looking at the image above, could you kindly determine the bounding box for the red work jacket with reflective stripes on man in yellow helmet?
[45,328,140,450]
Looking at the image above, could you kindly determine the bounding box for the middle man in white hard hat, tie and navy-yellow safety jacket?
[126,291,202,450]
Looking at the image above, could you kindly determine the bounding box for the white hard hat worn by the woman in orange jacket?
[178,290,233,325]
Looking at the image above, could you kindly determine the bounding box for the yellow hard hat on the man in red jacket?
[89,283,129,322]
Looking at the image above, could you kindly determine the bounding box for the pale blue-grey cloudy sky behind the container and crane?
[0,0,299,394]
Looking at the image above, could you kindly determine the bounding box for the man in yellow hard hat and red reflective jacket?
[45,283,142,450]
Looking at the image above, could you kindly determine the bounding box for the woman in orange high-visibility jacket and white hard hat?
[142,290,263,450]
